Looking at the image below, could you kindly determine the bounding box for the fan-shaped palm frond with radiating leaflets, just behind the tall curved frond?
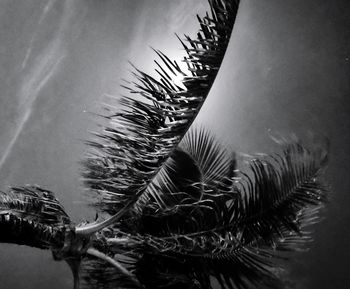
[133,128,236,236]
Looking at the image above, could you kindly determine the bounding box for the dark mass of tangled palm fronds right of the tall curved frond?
[78,130,327,288]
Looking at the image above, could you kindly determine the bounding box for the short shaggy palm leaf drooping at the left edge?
[0,186,70,249]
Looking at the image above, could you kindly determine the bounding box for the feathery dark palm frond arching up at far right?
[235,143,327,243]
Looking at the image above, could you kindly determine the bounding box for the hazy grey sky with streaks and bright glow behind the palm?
[0,0,350,289]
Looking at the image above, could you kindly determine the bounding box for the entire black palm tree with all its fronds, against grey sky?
[0,0,327,289]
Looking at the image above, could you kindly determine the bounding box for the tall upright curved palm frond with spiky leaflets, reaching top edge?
[83,0,238,214]
